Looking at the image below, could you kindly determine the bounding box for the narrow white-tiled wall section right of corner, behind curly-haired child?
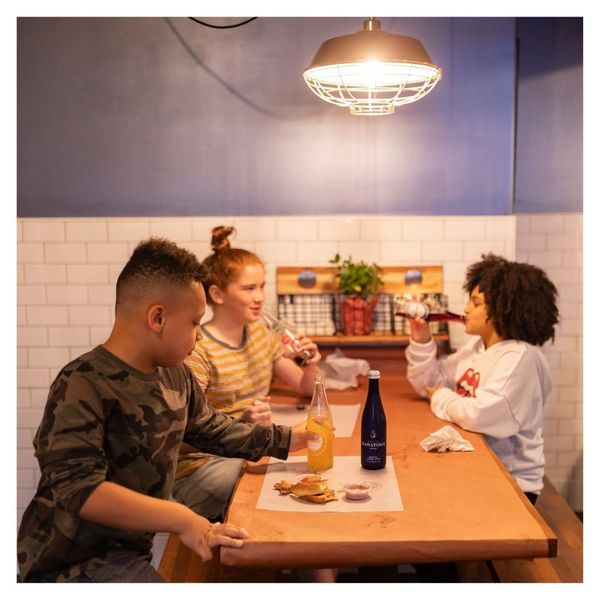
[516,214,583,510]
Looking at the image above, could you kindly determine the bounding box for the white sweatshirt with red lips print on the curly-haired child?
[406,337,552,494]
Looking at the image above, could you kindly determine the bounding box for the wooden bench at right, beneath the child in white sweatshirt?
[458,478,583,583]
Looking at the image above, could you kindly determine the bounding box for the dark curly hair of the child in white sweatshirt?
[464,254,559,346]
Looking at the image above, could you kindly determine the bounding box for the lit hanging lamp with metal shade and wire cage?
[304,18,442,115]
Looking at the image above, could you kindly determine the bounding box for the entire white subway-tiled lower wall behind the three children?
[16,214,583,520]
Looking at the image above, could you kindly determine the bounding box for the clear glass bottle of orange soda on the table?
[306,375,333,471]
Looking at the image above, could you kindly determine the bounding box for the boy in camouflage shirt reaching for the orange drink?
[18,239,306,582]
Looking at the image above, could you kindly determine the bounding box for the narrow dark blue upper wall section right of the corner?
[515,18,583,213]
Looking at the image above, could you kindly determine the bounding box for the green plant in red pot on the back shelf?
[329,254,383,335]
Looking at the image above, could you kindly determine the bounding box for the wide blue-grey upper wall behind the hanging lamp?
[17,18,580,217]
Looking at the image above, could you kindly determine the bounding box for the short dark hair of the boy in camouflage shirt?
[115,237,206,311]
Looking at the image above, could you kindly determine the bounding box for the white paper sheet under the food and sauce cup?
[256,456,404,513]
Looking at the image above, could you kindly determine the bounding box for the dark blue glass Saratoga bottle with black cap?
[360,370,387,471]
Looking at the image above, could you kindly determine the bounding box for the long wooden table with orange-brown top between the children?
[220,359,557,568]
